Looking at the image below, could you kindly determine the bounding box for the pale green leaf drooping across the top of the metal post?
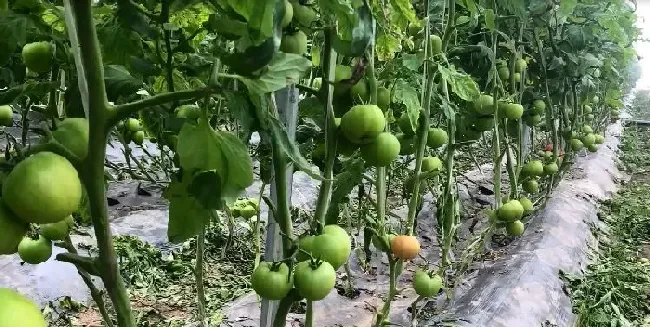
[241,52,311,94]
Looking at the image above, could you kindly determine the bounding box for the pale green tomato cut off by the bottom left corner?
[0,288,47,327]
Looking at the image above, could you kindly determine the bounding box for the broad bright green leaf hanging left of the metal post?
[177,119,253,198]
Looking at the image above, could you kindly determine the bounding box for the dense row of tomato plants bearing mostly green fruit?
[0,0,638,327]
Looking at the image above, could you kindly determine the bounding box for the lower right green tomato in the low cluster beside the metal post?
[294,261,336,301]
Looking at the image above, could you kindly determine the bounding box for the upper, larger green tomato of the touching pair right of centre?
[341,105,386,144]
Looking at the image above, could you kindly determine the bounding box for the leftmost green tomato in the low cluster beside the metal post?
[251,262,293,301]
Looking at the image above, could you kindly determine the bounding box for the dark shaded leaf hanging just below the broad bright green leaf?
[163,173,213,243]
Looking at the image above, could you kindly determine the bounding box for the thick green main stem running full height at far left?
[72,0,135,327]
